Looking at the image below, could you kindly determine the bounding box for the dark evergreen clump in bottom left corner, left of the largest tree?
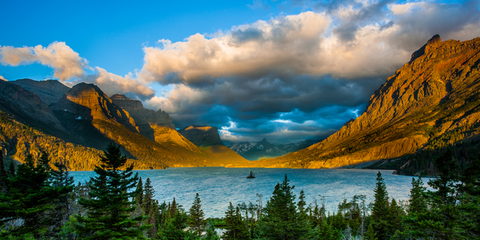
[0,152,73,238]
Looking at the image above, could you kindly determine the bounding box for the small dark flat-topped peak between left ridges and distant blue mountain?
[178,125,223,147]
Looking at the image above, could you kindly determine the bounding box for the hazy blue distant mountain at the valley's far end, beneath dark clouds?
[230,138,319,160]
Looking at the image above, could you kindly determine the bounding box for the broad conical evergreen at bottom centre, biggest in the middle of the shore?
[260,174,307,239]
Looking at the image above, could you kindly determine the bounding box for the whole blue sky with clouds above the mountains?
[0,0,480,144]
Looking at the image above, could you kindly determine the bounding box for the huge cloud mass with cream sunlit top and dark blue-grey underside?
[141,1,480,142]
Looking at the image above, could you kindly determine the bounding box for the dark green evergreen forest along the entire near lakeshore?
[0,145,480,240]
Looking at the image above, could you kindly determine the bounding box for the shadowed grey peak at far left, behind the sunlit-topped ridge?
[10,79,70,105]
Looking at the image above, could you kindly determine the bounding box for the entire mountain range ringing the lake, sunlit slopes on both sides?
[0,35,480,174]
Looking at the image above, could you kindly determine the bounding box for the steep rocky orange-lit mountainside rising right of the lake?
[256,35,480,168]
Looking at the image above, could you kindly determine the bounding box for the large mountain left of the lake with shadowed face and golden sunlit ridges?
[0,81,248,170]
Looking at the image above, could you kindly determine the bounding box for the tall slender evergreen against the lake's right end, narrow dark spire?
[372,172,390,240]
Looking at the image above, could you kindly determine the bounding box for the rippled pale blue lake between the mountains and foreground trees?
[70,167,422,217]
